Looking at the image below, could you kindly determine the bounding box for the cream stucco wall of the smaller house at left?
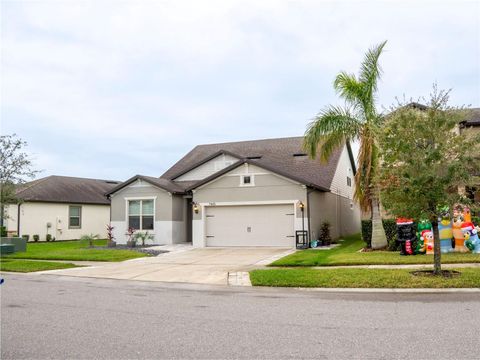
[7,202,110,241]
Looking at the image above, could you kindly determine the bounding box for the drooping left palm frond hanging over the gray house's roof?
[303,106,361,161]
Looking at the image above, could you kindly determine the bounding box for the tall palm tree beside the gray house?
[304,41,387,249]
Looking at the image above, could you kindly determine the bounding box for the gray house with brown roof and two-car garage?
[107,137,360,247]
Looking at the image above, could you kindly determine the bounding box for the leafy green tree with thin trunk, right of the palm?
[378,87,480,274]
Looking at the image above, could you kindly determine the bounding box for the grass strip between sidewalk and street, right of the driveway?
[250,268,480,288]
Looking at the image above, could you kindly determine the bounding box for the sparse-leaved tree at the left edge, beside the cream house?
[0,134,38,226]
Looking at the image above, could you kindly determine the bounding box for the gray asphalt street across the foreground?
[0,274,480,359]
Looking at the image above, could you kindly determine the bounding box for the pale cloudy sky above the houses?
[0,0,480,180]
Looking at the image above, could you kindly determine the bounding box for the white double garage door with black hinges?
[205,205,295,247]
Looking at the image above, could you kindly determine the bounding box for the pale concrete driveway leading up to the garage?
[43,248,294,285]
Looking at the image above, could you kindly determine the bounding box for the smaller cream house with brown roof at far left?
[5,176,119,241]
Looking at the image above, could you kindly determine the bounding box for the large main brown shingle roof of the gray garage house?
[161,136,346,191]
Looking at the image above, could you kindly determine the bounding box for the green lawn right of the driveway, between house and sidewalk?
[270,235,480,267]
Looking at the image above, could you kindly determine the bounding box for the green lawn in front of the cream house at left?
[3,240,147,261]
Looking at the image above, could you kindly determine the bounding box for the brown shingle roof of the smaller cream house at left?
[17,175,120,205]
